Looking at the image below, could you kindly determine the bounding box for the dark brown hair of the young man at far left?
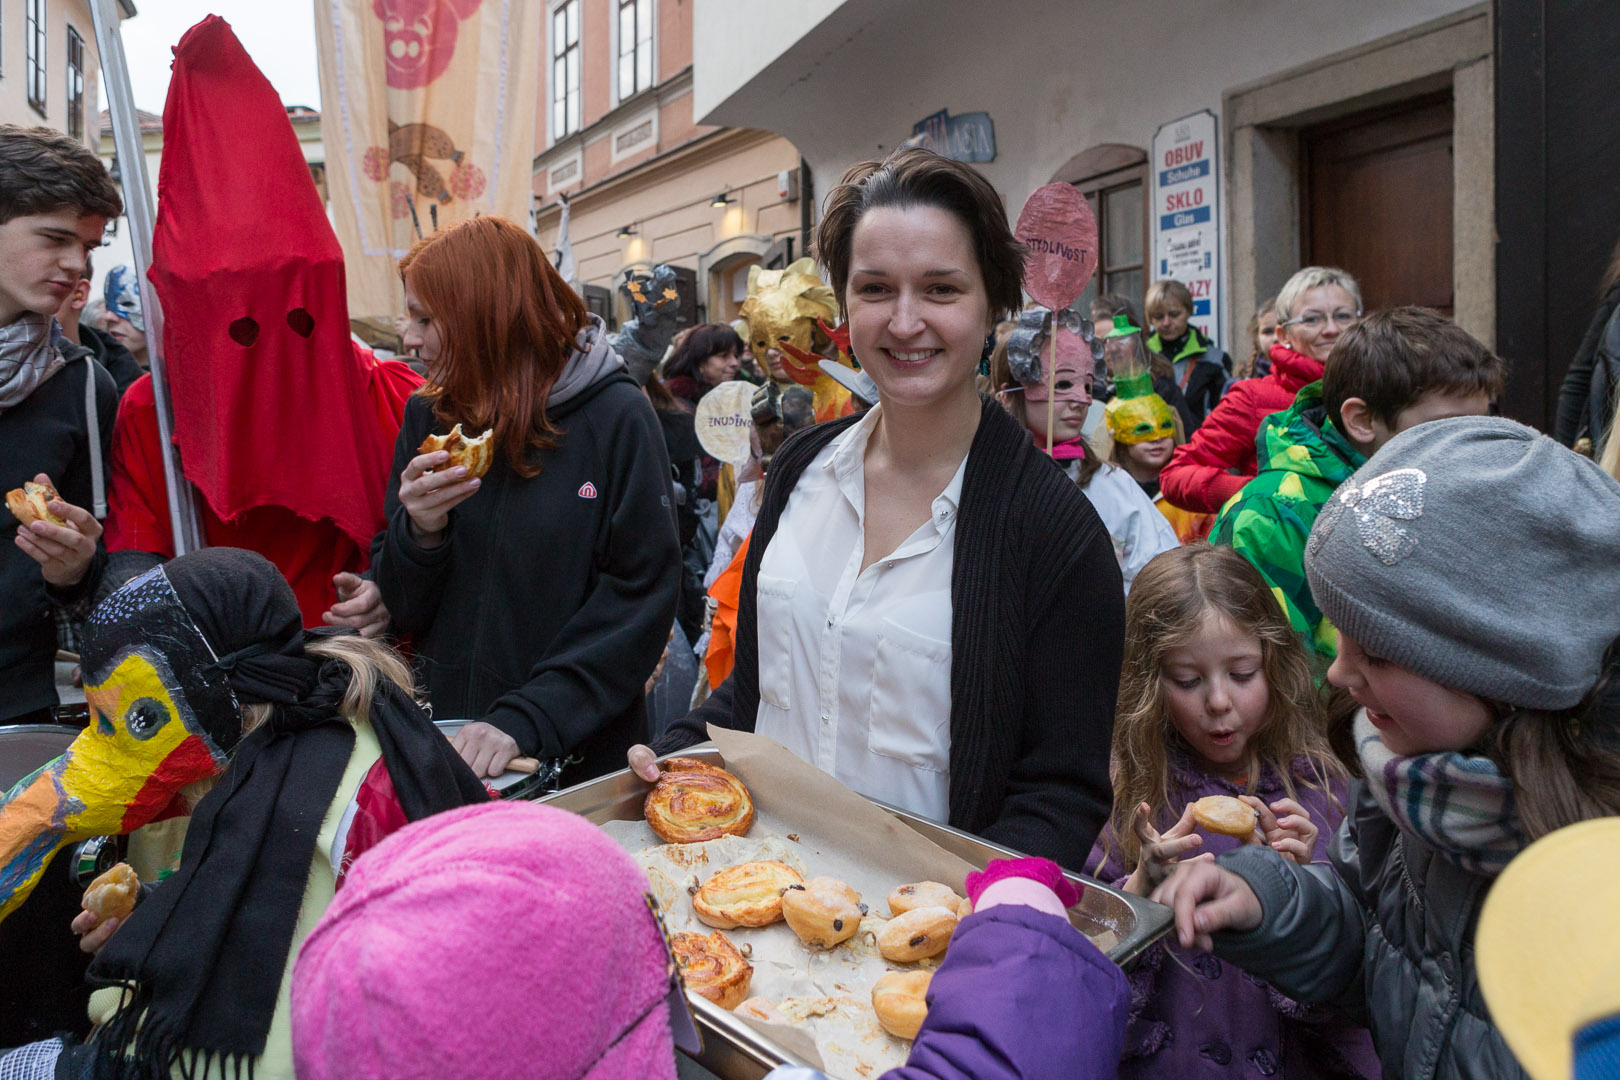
[0,123,123,225]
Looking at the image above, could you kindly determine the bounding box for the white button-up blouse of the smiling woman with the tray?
[755,408,967,821]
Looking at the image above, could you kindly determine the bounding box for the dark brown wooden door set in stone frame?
[1301,96,1453,316]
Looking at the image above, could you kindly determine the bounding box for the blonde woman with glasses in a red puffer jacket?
[1158,266,1361,513]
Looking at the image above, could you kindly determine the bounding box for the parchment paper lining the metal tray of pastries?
[601,727,974,1080]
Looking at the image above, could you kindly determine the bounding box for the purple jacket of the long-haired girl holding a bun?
[1085,755,1379,1080]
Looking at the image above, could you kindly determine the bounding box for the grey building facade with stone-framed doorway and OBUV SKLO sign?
[692,0,1495,393]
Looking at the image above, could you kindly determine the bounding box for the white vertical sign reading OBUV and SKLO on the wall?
[1150,110,1226,345]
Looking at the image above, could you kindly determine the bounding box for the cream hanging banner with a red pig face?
[314,0,539,317]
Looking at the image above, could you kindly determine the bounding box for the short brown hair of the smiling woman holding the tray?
[815,147,1024,319]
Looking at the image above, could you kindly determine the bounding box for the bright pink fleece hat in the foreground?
[292,801,676,1080]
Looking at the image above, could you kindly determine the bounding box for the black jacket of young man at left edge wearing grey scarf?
[0,354,118,724]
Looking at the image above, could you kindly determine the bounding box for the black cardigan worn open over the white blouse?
[653,398,1124,870]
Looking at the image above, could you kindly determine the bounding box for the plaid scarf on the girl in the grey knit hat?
[1356,711,1526,878]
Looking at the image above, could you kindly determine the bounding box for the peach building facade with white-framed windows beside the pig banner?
[535,0,810,324]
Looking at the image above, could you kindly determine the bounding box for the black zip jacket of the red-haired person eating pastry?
[371,369,680,784]
